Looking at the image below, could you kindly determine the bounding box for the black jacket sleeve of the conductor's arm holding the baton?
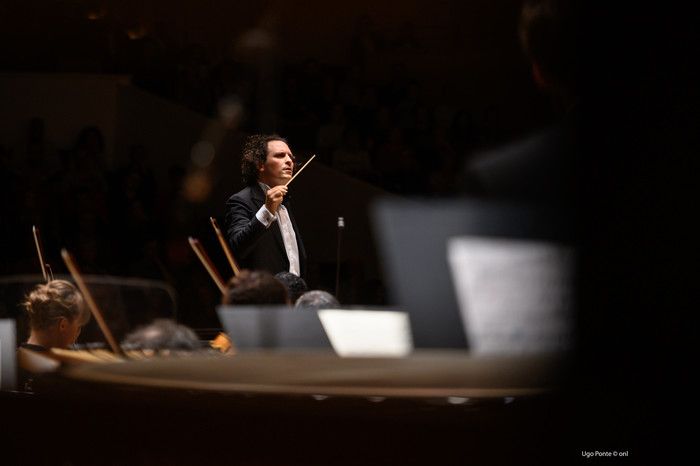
[226,196,267,258]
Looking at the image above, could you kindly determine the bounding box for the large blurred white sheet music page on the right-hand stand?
[447,236,574,354]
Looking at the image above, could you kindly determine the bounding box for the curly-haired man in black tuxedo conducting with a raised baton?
[226,135,306,278]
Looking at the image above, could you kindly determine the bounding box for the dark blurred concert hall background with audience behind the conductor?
[0,0,554,327]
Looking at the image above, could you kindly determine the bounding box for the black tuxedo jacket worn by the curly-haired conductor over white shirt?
[226,183,306,278]
